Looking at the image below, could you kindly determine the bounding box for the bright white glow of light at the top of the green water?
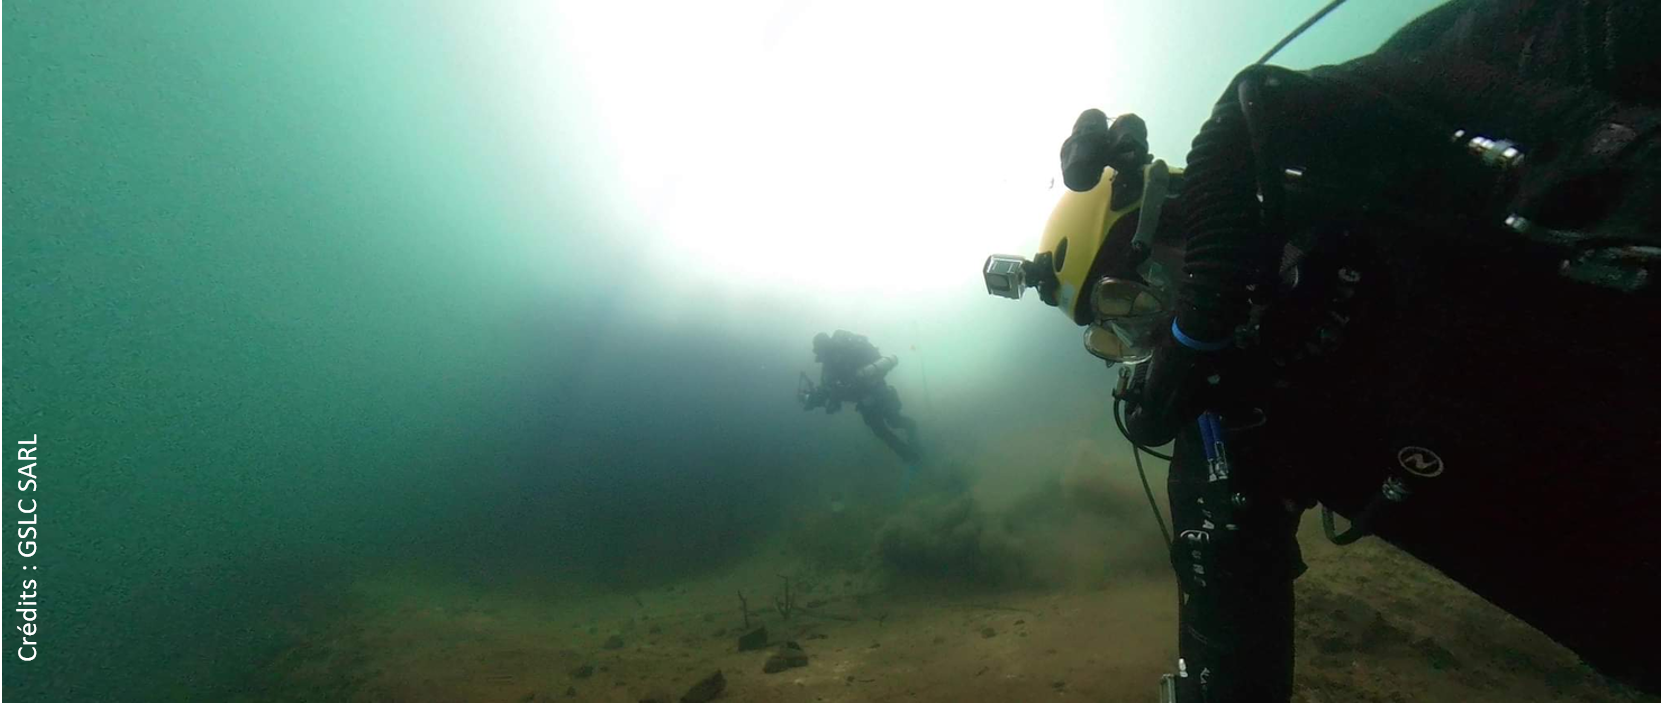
[468,3,1106,297]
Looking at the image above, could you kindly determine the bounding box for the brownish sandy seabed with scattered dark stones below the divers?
[244,520,1658,703]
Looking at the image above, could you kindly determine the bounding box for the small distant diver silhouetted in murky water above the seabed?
[796,329,922,475]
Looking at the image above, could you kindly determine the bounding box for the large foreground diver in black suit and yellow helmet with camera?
[983,0,1661,703]
